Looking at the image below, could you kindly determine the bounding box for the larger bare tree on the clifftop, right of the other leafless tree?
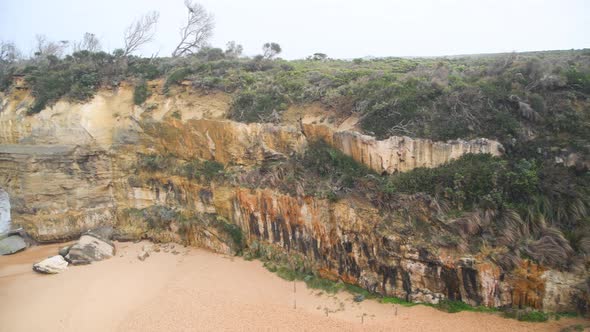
[172,0,215,57]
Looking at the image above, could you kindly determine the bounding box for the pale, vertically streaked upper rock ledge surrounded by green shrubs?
[303,124,503,174]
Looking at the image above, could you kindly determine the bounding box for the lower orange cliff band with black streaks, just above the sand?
[122,183,587,311]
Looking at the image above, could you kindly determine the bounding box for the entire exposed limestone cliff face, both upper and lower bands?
[0,86,587,310]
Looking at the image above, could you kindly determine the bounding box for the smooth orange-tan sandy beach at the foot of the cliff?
[0,243,587,332]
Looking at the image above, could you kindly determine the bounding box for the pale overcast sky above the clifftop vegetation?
[0,0,590,59]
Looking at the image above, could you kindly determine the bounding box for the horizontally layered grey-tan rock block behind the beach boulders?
[0,144,114,242]
